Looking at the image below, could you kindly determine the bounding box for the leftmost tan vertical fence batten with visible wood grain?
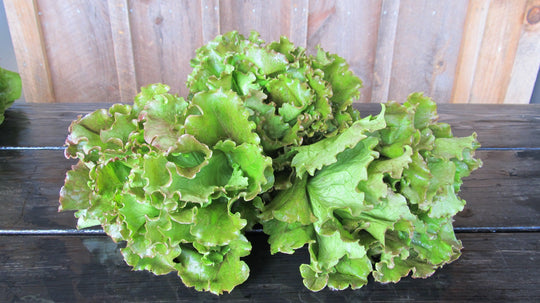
[2,0,56,103]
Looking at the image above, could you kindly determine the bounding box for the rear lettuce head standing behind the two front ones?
[188,31,362,188]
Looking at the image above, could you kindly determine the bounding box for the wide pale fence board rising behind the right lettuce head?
[389,0,468,103]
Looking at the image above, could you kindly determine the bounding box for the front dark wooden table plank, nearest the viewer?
[0,233,540,302]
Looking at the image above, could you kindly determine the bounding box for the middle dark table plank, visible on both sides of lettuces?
[0,150,540,230]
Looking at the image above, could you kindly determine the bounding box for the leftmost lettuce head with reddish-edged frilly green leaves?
[60,84,273,293]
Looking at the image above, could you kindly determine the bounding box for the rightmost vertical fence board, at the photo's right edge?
[504,0,540,104]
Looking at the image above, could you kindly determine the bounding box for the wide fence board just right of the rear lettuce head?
[307,0,381,102]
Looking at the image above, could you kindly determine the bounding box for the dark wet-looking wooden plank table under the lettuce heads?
[0,103,540,302]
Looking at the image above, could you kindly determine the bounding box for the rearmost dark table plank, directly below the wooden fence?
[0,103,540,148]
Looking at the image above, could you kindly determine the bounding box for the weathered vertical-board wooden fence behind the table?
[3,0,540,103]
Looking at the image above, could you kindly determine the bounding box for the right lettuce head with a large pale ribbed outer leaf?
[260,93,481,291]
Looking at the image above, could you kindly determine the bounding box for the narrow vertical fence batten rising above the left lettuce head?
[107,0,138,103]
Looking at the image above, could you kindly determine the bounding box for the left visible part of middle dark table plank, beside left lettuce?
[0,150,76,230]
